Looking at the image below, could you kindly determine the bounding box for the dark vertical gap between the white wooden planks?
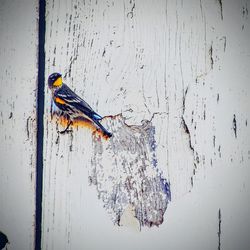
[35,0,46,250]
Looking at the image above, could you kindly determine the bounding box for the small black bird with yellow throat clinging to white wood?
[48,73,112,137]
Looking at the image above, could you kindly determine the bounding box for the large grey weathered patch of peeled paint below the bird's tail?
[89,115,171,227]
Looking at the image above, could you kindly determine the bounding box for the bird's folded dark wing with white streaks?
[54,84,102,120]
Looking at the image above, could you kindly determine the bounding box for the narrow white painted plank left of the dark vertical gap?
[0,0,38,250]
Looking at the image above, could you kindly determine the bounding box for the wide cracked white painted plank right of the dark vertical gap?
[43,0,250,249]
